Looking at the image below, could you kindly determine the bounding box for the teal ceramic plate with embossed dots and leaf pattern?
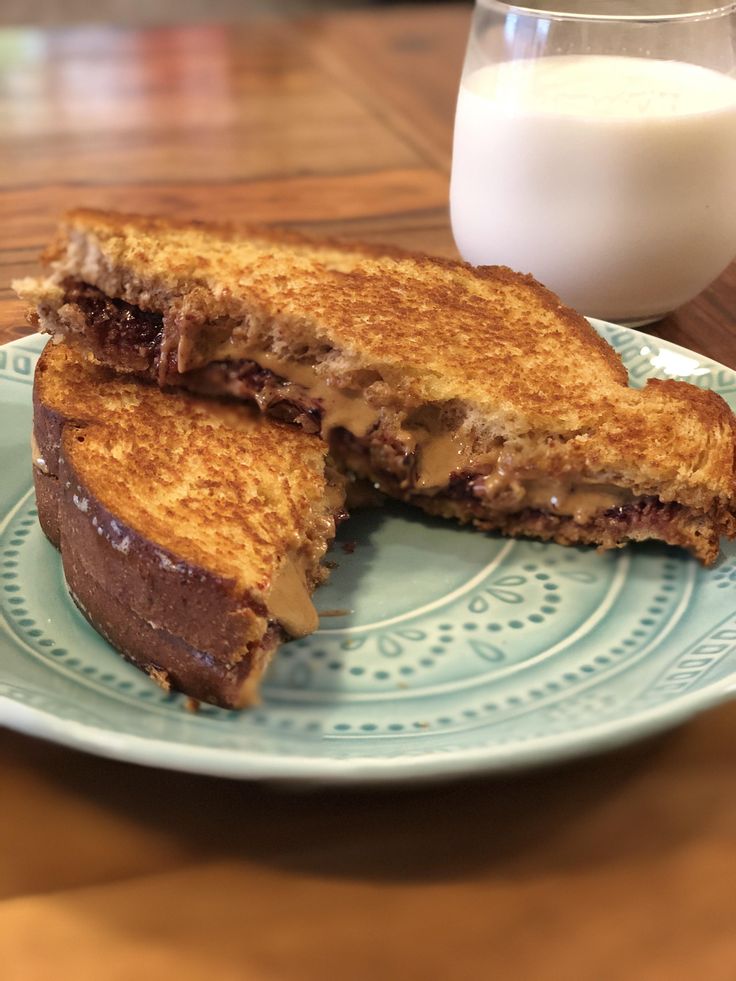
[0,330,736,782]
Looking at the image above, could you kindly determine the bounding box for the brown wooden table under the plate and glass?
[0,6,736,981]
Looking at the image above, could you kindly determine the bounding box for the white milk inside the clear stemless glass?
[451,55,736,320]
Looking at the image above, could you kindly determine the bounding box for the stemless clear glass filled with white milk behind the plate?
[450,0,736,324]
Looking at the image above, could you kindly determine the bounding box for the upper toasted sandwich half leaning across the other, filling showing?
[17,210,736,564]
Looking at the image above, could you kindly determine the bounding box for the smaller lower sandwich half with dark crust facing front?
[33,343,344,708]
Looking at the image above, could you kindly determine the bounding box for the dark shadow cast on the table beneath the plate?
[2,708,713,883]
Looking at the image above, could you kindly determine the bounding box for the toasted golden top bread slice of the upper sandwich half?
[21,211,736,562]
